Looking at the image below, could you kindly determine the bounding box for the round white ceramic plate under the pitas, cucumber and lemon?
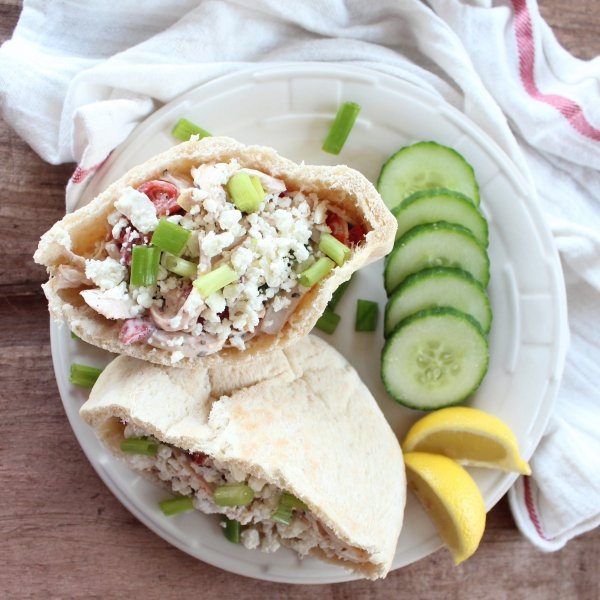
[51,64,568,583]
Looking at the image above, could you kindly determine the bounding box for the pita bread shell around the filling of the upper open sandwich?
[34,137,397,367]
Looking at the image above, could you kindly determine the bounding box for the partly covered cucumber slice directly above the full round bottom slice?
[384,267,492,337]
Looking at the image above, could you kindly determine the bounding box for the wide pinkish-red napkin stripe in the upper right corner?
[513,0,600,142]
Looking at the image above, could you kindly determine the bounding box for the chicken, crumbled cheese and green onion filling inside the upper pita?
[65,159,366,363]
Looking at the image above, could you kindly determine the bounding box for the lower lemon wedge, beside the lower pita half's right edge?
[404,452,485,565]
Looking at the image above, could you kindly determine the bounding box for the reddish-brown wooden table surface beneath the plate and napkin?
[0,0,600,600]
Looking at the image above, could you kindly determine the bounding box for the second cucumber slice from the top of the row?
[392,189,488,248]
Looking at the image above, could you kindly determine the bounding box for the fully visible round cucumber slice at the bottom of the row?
[381,308,489,410]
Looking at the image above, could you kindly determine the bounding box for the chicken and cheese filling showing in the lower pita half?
[119,422,368,563]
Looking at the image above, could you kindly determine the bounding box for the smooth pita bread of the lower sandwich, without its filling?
[80,336,406,579]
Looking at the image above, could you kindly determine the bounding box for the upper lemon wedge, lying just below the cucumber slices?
[402,406,531,475]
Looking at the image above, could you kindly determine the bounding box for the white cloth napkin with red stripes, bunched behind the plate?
[0,0,600,550]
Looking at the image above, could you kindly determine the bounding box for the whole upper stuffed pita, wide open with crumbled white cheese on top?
[34,137,396,366]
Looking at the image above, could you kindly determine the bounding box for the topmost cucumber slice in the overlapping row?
[377,142,479,210]
